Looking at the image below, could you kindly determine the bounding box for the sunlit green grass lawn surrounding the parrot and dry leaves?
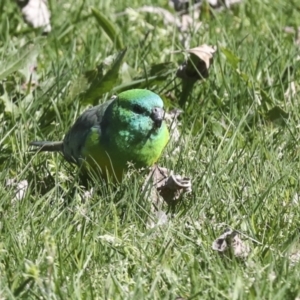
[0,0,300,300]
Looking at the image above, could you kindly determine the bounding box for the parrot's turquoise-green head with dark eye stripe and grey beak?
[114,89,165,135]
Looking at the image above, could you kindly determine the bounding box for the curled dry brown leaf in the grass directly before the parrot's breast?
[144,166,192,208]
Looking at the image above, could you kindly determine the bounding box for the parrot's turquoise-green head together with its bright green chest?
[102,89,170,170]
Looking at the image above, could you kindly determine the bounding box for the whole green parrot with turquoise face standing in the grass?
[30,89,169,181]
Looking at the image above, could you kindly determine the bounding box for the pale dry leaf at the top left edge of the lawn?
[17,0,51,33]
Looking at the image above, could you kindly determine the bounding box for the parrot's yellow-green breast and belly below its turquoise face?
[82,123,169,180]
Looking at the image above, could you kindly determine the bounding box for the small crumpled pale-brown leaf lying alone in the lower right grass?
[212,228,250,258]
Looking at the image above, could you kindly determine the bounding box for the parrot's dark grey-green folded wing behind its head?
[63,99,114,164]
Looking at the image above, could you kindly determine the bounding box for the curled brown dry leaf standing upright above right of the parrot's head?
[176,44,217,81]
